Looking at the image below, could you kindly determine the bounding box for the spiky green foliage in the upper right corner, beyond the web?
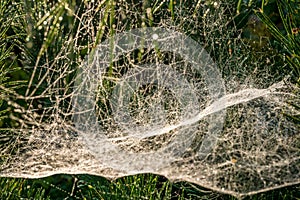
[236,0,300,128]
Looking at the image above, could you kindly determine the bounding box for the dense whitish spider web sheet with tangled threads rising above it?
[0,1,300,197]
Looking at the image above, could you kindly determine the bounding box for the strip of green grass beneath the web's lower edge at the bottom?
[0,174,300,200]
